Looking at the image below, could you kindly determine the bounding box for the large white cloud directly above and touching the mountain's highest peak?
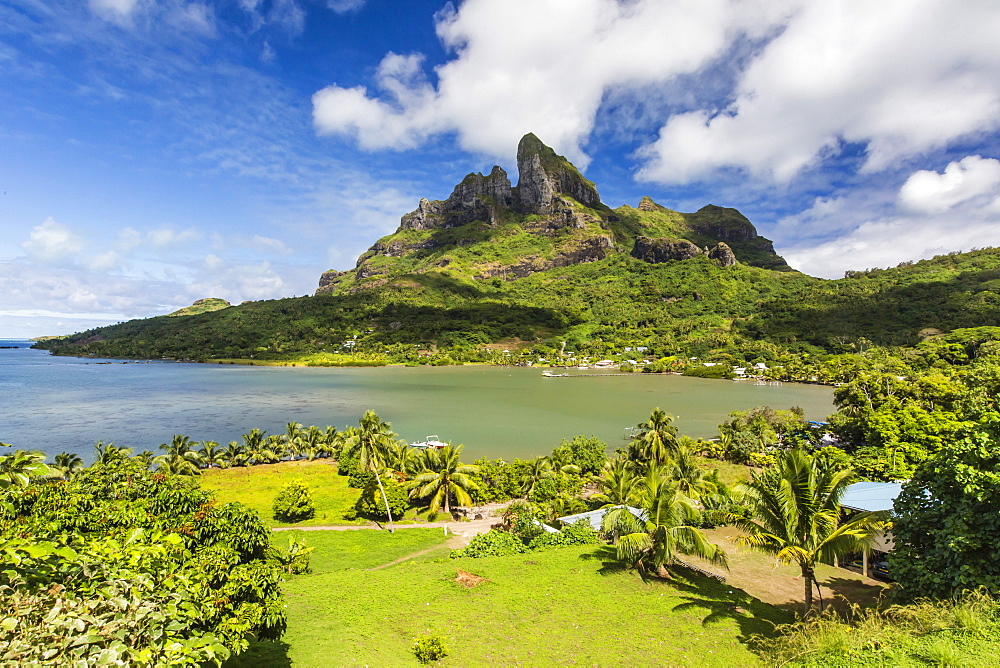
[313,0,783,163]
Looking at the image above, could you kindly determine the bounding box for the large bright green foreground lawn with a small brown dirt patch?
[230,540,791,666]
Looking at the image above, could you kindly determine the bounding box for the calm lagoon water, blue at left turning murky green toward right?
[0,340,833,461]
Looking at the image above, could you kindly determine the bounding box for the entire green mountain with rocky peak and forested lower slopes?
[33,135,1000,361]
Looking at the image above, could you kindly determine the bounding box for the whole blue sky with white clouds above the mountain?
[0,0,1000,337]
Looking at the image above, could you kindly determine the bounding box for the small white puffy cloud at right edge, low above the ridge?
[899,155,1000,213]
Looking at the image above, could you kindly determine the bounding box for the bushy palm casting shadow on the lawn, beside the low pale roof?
[602,468,728,576]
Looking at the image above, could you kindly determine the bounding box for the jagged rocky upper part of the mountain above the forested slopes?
[316,133,789,294]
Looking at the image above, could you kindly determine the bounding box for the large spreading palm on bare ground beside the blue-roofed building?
[734,448,888,615]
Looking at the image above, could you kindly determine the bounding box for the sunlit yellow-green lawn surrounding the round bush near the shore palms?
[201,459,368,526]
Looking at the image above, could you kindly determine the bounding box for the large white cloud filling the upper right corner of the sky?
[639,0,1000,183]
